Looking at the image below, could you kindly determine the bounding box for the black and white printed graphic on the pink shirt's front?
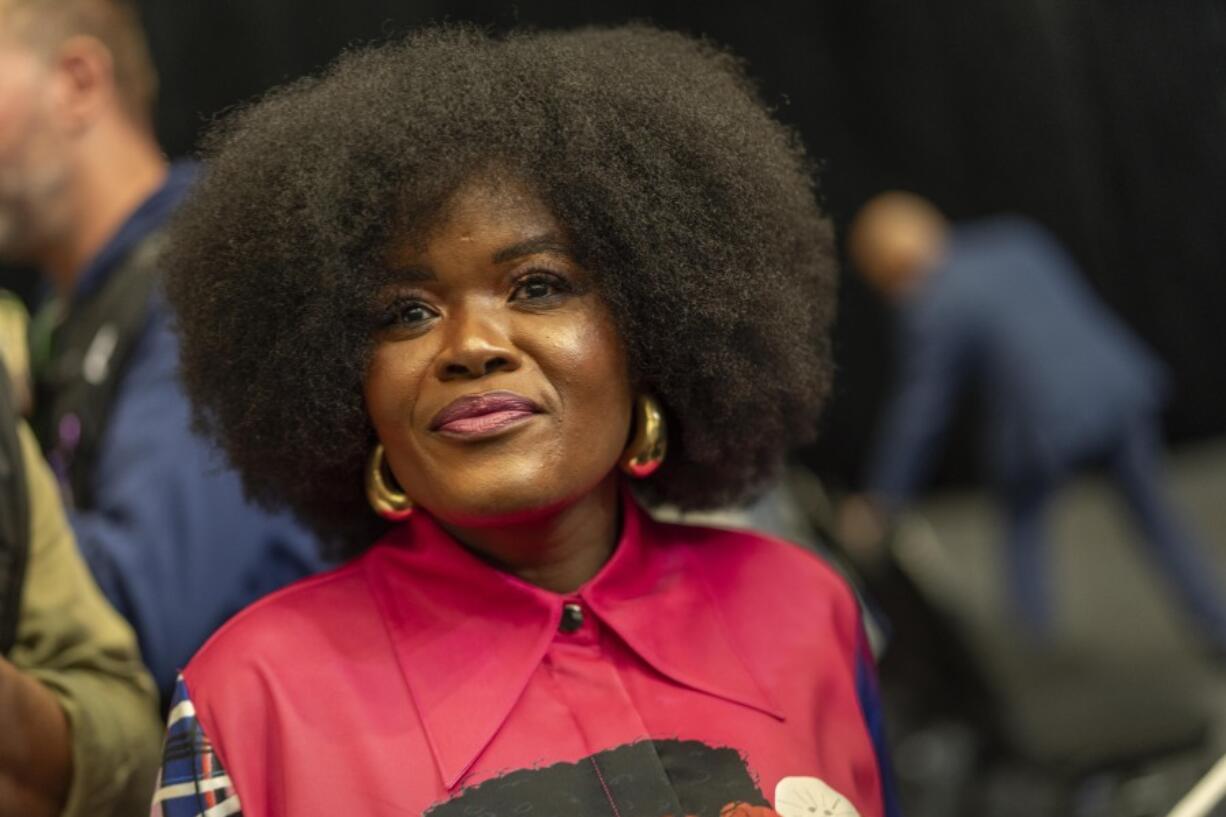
[425,740,859,817]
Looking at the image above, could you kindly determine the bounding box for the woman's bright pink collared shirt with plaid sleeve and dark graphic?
[154,490,896,817]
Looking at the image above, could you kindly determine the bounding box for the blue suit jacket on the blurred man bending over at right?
[868,217,1166,508]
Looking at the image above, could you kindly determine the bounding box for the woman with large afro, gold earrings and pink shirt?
[154,26,896,817]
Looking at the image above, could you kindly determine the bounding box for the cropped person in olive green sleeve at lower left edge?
[0,333,161,817]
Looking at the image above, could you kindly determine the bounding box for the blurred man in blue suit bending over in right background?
[845,193,1226,651]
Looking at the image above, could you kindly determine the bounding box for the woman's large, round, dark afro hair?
[166,25,835,554]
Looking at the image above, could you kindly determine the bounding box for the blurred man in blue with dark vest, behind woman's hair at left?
[0,0,316,693]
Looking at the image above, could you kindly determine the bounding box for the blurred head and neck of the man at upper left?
[0,0,166,283]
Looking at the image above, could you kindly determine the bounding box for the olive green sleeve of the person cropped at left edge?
[7,426,162,817]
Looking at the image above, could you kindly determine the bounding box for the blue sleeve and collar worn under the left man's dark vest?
[59,166,321,694]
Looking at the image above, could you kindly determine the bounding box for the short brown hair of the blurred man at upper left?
[0,0,157,126]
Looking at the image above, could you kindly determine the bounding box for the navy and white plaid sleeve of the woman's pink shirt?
[151,675,243,817]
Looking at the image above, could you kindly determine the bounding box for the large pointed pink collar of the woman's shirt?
[364,491,782,789]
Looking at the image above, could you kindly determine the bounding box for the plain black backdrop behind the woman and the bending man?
[9,0,1226,490]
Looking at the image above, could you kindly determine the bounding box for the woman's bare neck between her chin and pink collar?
[440,474,622,593]
